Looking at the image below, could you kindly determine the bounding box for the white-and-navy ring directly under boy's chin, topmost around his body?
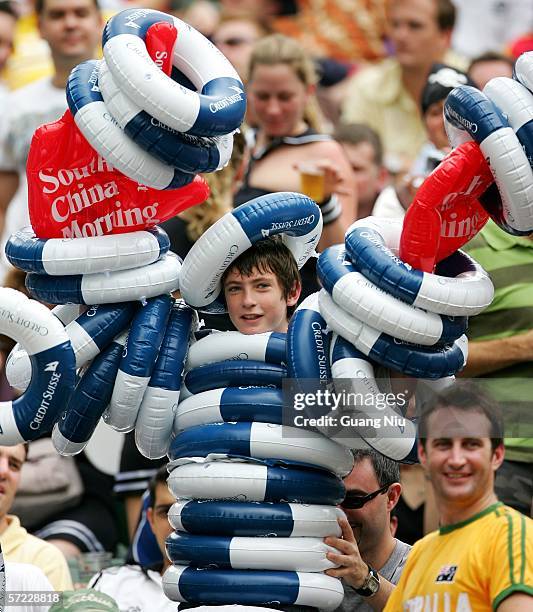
[185,331,287,370]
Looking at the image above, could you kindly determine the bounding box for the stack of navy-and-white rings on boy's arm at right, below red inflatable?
[287,217,493,462]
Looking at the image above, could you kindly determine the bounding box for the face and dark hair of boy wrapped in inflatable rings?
[222,237,302,334]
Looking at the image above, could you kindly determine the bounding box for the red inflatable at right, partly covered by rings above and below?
[400,141,494,272]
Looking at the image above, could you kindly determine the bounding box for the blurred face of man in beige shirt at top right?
[389,0,450,69]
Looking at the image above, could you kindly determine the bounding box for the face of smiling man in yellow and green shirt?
[419,407,504,508]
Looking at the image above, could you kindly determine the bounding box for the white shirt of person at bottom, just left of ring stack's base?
[87,565,179,612]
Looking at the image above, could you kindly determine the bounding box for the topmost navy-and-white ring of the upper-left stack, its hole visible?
[102,9,246,136]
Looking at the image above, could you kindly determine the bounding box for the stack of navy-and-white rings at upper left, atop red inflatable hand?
[67,9,246,189]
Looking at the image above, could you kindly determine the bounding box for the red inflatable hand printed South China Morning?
[26,110,209,238]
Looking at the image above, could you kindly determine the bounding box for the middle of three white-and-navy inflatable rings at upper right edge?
[483,77,533,165]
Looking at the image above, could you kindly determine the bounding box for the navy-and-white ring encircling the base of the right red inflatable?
[346,217,494,316]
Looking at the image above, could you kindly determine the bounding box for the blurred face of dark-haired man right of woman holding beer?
[341,142,384,216]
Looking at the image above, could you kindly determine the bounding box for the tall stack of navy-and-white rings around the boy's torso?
[163,332,353,609]
